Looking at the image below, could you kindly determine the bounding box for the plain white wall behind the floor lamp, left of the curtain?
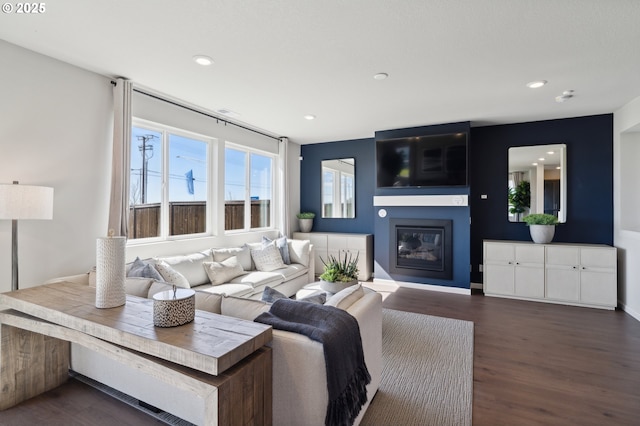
[0,40,113,291]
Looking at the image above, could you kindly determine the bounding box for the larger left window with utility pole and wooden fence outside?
[129,125,210,239]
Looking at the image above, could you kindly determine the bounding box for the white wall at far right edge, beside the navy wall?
[613,98,640,321]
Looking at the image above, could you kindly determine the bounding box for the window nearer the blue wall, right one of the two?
[224,144,274,231]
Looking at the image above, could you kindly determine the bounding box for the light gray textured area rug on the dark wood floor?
[361,309,473,426]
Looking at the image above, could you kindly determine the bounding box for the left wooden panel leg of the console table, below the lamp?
[0,324,70,411]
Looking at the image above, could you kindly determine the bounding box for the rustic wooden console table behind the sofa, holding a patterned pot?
[0,282,272,425]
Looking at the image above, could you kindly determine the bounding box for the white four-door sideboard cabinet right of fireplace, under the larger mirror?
[483,240,618,309]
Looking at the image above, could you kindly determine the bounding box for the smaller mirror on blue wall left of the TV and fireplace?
[321,158,356,218]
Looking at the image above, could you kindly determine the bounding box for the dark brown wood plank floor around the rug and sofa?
[0,288,640,426]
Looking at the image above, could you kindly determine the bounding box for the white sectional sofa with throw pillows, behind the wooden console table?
[51,240,382,426]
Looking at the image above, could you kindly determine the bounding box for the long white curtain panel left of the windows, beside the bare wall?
[107,78,133,237]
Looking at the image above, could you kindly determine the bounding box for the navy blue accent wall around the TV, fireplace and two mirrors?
[300,114,613,288]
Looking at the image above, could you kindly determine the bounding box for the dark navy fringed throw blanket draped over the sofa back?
[255,299,371,426]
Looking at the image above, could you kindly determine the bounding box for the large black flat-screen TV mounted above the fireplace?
[376,133,468,188]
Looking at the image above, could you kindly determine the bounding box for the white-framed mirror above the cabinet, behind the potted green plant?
[507,144,567,223]
